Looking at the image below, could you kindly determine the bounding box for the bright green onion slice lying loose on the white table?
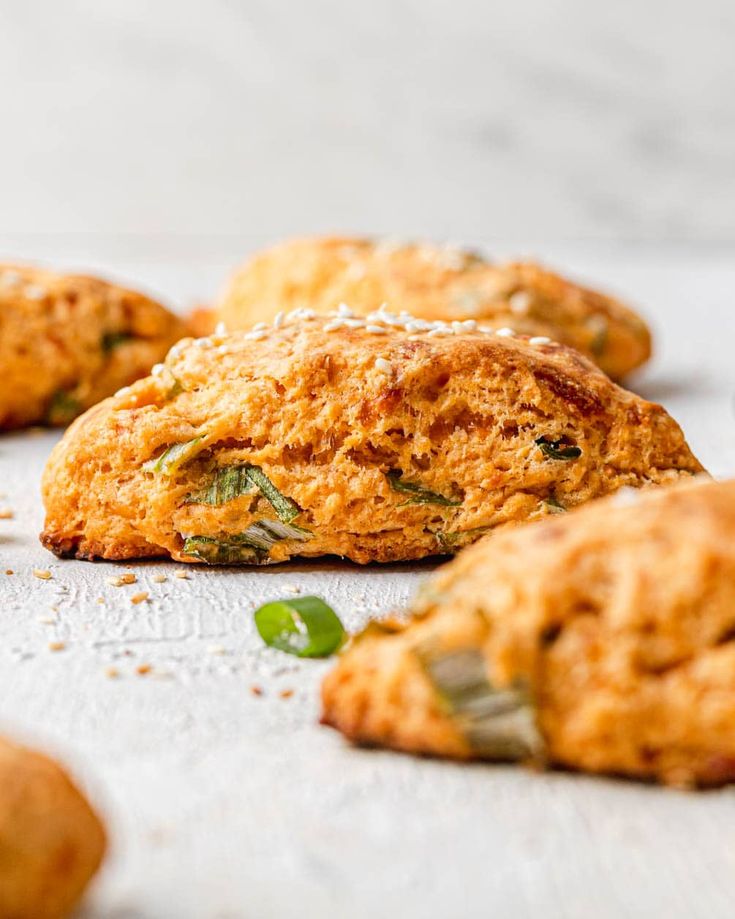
[255,597,347,657]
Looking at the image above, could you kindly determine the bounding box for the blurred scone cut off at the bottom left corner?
[0,738,106,919]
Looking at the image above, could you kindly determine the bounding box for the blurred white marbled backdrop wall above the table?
[0,0,735,249]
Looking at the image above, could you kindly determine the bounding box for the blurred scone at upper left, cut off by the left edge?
[0,264,186,430]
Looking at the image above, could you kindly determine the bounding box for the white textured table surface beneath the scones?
[0,246,735,919]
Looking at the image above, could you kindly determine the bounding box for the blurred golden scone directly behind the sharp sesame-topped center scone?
[218,238,651,379]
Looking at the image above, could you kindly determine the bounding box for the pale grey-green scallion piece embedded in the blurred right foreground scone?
[418,648,544,760]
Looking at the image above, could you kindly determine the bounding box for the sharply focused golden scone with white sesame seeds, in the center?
[42,310,701,564]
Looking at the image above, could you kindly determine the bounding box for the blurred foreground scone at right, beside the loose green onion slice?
[323,480,735,786]
